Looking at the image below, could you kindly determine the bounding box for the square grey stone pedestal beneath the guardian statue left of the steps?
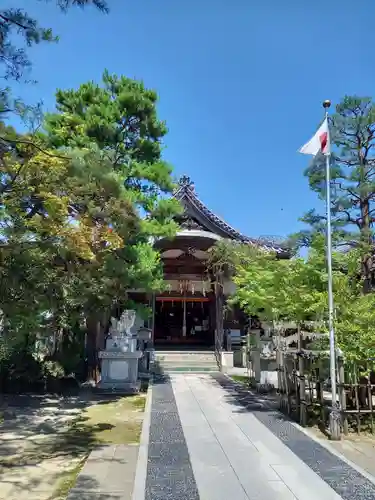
[97,348,142,393]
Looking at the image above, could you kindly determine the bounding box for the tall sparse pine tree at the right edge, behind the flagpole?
[297,96,375,292]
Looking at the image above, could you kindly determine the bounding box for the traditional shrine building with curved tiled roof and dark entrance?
[129,176,287,350]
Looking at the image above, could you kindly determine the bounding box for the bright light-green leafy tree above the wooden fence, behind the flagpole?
[211,235,375,363]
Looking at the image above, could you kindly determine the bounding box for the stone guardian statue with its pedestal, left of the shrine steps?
[97,310,142,393]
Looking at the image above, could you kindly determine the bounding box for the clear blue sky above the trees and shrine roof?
[2,0,375,242]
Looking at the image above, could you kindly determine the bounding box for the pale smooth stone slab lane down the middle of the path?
[173,376,346,500]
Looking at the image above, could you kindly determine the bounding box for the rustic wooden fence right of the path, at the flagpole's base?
[274,325,375,434]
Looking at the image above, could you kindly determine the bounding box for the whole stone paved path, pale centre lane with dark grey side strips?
[133,374,375,500]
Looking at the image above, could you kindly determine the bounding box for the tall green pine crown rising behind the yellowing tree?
[45,72,180,238]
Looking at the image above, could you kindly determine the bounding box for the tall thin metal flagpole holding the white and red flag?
[323,100,341,440]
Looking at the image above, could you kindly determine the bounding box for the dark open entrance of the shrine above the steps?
[154,296,215,348]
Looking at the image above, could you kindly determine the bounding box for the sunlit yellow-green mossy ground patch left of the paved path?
[0,393,146,500]
